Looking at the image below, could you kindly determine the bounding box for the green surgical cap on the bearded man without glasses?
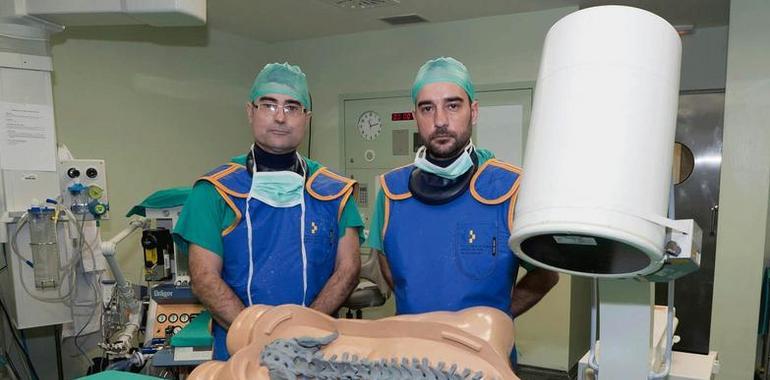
[412,57,476,102]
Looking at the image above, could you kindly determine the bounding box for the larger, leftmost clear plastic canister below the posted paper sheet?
[29,207,61,289]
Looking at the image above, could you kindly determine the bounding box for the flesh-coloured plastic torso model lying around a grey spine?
[190,305,518,380]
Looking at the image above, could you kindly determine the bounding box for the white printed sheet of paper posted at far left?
[0,102,56,172]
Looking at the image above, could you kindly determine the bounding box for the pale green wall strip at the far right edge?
[711,0,770,379]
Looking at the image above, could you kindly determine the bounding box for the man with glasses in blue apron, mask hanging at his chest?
[174,63,363,360]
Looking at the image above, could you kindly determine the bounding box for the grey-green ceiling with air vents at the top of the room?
[208,0,730,42]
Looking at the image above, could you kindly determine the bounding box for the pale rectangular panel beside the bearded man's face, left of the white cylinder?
[474,104,524,166]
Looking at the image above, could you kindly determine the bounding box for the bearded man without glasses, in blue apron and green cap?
[367,57,559,365]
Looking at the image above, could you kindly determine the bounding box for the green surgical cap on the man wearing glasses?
[249,63,312,109]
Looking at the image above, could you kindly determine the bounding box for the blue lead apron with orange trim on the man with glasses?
[199,163,355,360]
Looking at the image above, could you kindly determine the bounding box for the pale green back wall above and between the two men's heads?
[270,8,575,169]
